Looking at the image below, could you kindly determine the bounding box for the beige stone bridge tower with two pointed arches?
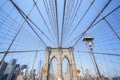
[42,47,77,80]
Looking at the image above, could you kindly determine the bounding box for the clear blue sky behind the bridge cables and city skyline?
[0,0,120,76]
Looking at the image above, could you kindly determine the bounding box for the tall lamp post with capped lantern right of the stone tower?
[83,35,101,80]
